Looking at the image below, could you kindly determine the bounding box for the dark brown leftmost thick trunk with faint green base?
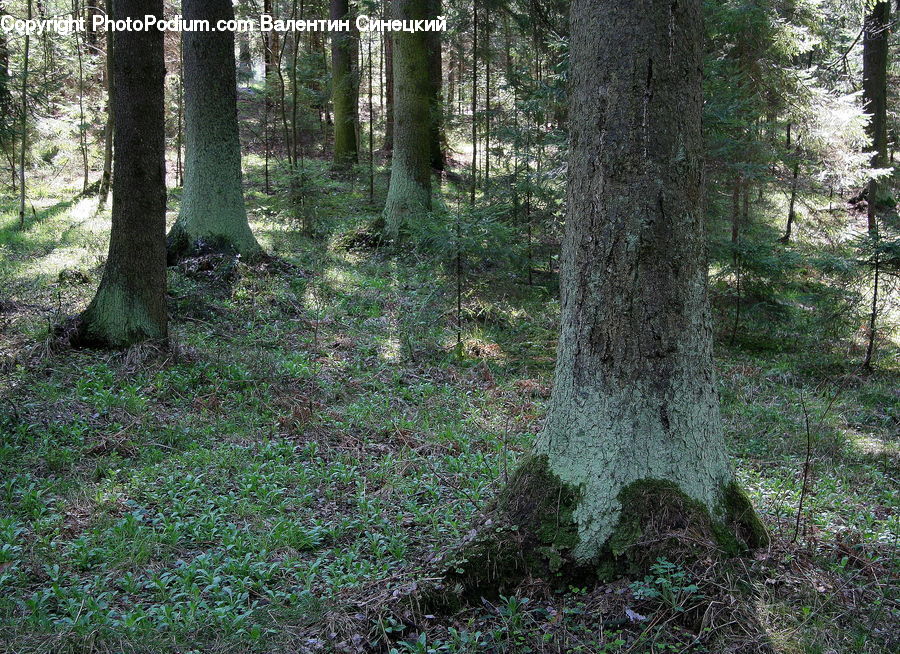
[73,0,167,347]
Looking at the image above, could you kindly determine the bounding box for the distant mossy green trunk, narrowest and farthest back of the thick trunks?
[331,0,359,168]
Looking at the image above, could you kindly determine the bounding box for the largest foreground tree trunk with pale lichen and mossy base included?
[451,0,766,589]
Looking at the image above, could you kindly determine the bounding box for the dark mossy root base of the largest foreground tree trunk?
[445,455,769,597]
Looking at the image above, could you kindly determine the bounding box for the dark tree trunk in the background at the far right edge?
[863,2,891,232]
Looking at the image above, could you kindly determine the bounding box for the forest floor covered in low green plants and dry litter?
[0,133,900,654]
